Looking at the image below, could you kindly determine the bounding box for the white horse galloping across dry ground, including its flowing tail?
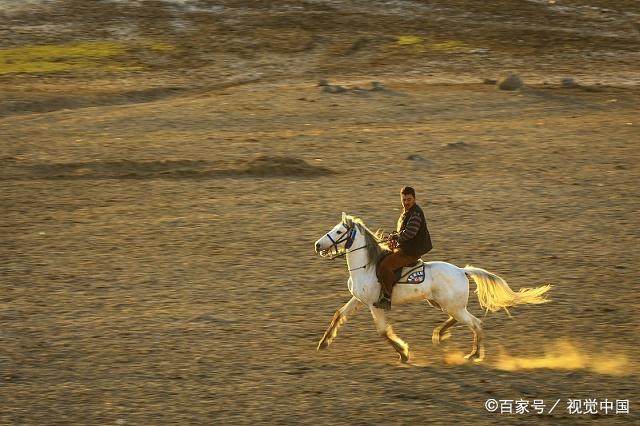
[315,213,551,362]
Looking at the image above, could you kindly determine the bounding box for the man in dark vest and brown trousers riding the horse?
[373,186,432,311]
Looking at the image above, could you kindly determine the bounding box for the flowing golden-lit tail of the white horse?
[463,265,551,314]
